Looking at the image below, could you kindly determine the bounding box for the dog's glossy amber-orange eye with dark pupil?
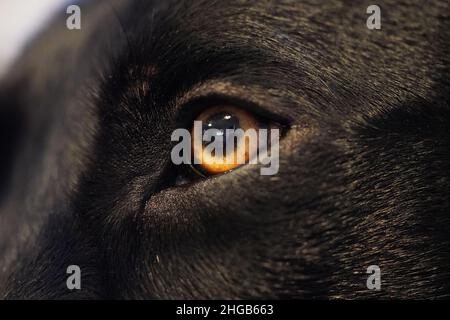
[191,106,267,175]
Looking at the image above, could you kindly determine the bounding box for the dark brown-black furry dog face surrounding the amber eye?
[0,1,450,298]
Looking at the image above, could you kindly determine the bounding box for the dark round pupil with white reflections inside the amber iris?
[202,112,240,154]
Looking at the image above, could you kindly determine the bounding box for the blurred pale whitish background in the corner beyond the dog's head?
[0,0,67,77]
